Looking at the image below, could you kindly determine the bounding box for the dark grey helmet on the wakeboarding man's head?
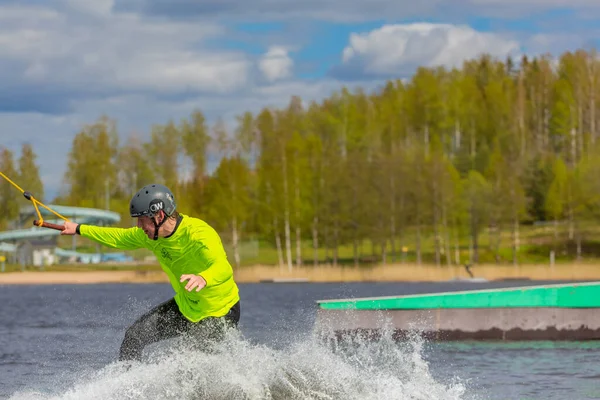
[129,184,177,218]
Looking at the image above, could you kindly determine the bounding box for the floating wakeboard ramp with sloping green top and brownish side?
[317,282,600,340]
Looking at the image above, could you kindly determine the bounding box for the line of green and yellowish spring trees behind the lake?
[0,50,600,268]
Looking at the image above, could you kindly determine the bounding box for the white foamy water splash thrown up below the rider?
[11,324,474,400]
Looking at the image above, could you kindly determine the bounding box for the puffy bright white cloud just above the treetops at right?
[338,23,519,76]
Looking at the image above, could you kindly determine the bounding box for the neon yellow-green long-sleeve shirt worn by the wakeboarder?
[79,214,240,322]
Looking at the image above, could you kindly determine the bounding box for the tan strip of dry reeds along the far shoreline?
[0,264,600,285]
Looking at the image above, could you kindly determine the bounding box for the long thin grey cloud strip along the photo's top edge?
[117,0,600,22]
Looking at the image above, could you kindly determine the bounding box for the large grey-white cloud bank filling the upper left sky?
[0,2,252,99]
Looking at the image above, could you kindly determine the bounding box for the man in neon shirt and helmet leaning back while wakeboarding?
[61,184,240,361]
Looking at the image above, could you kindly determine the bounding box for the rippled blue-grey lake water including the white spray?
[0,282,600,400]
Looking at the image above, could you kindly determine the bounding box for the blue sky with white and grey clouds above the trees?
[0,0,600,201]
